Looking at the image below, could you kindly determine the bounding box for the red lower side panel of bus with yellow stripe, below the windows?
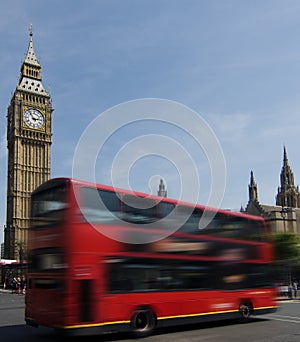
[102,289,276,325]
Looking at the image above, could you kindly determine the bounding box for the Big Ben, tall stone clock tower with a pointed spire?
[4,27,53,260]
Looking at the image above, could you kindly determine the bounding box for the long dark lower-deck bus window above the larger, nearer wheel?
[107,258,213,293]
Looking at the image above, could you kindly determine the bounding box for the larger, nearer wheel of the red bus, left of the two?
[131,309,156,337]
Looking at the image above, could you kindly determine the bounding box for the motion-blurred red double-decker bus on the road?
[25,178,276,337]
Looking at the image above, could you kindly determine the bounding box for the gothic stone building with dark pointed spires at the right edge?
[242,147,300,234]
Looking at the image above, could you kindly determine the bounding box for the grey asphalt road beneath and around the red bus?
[0,292,300,342]
